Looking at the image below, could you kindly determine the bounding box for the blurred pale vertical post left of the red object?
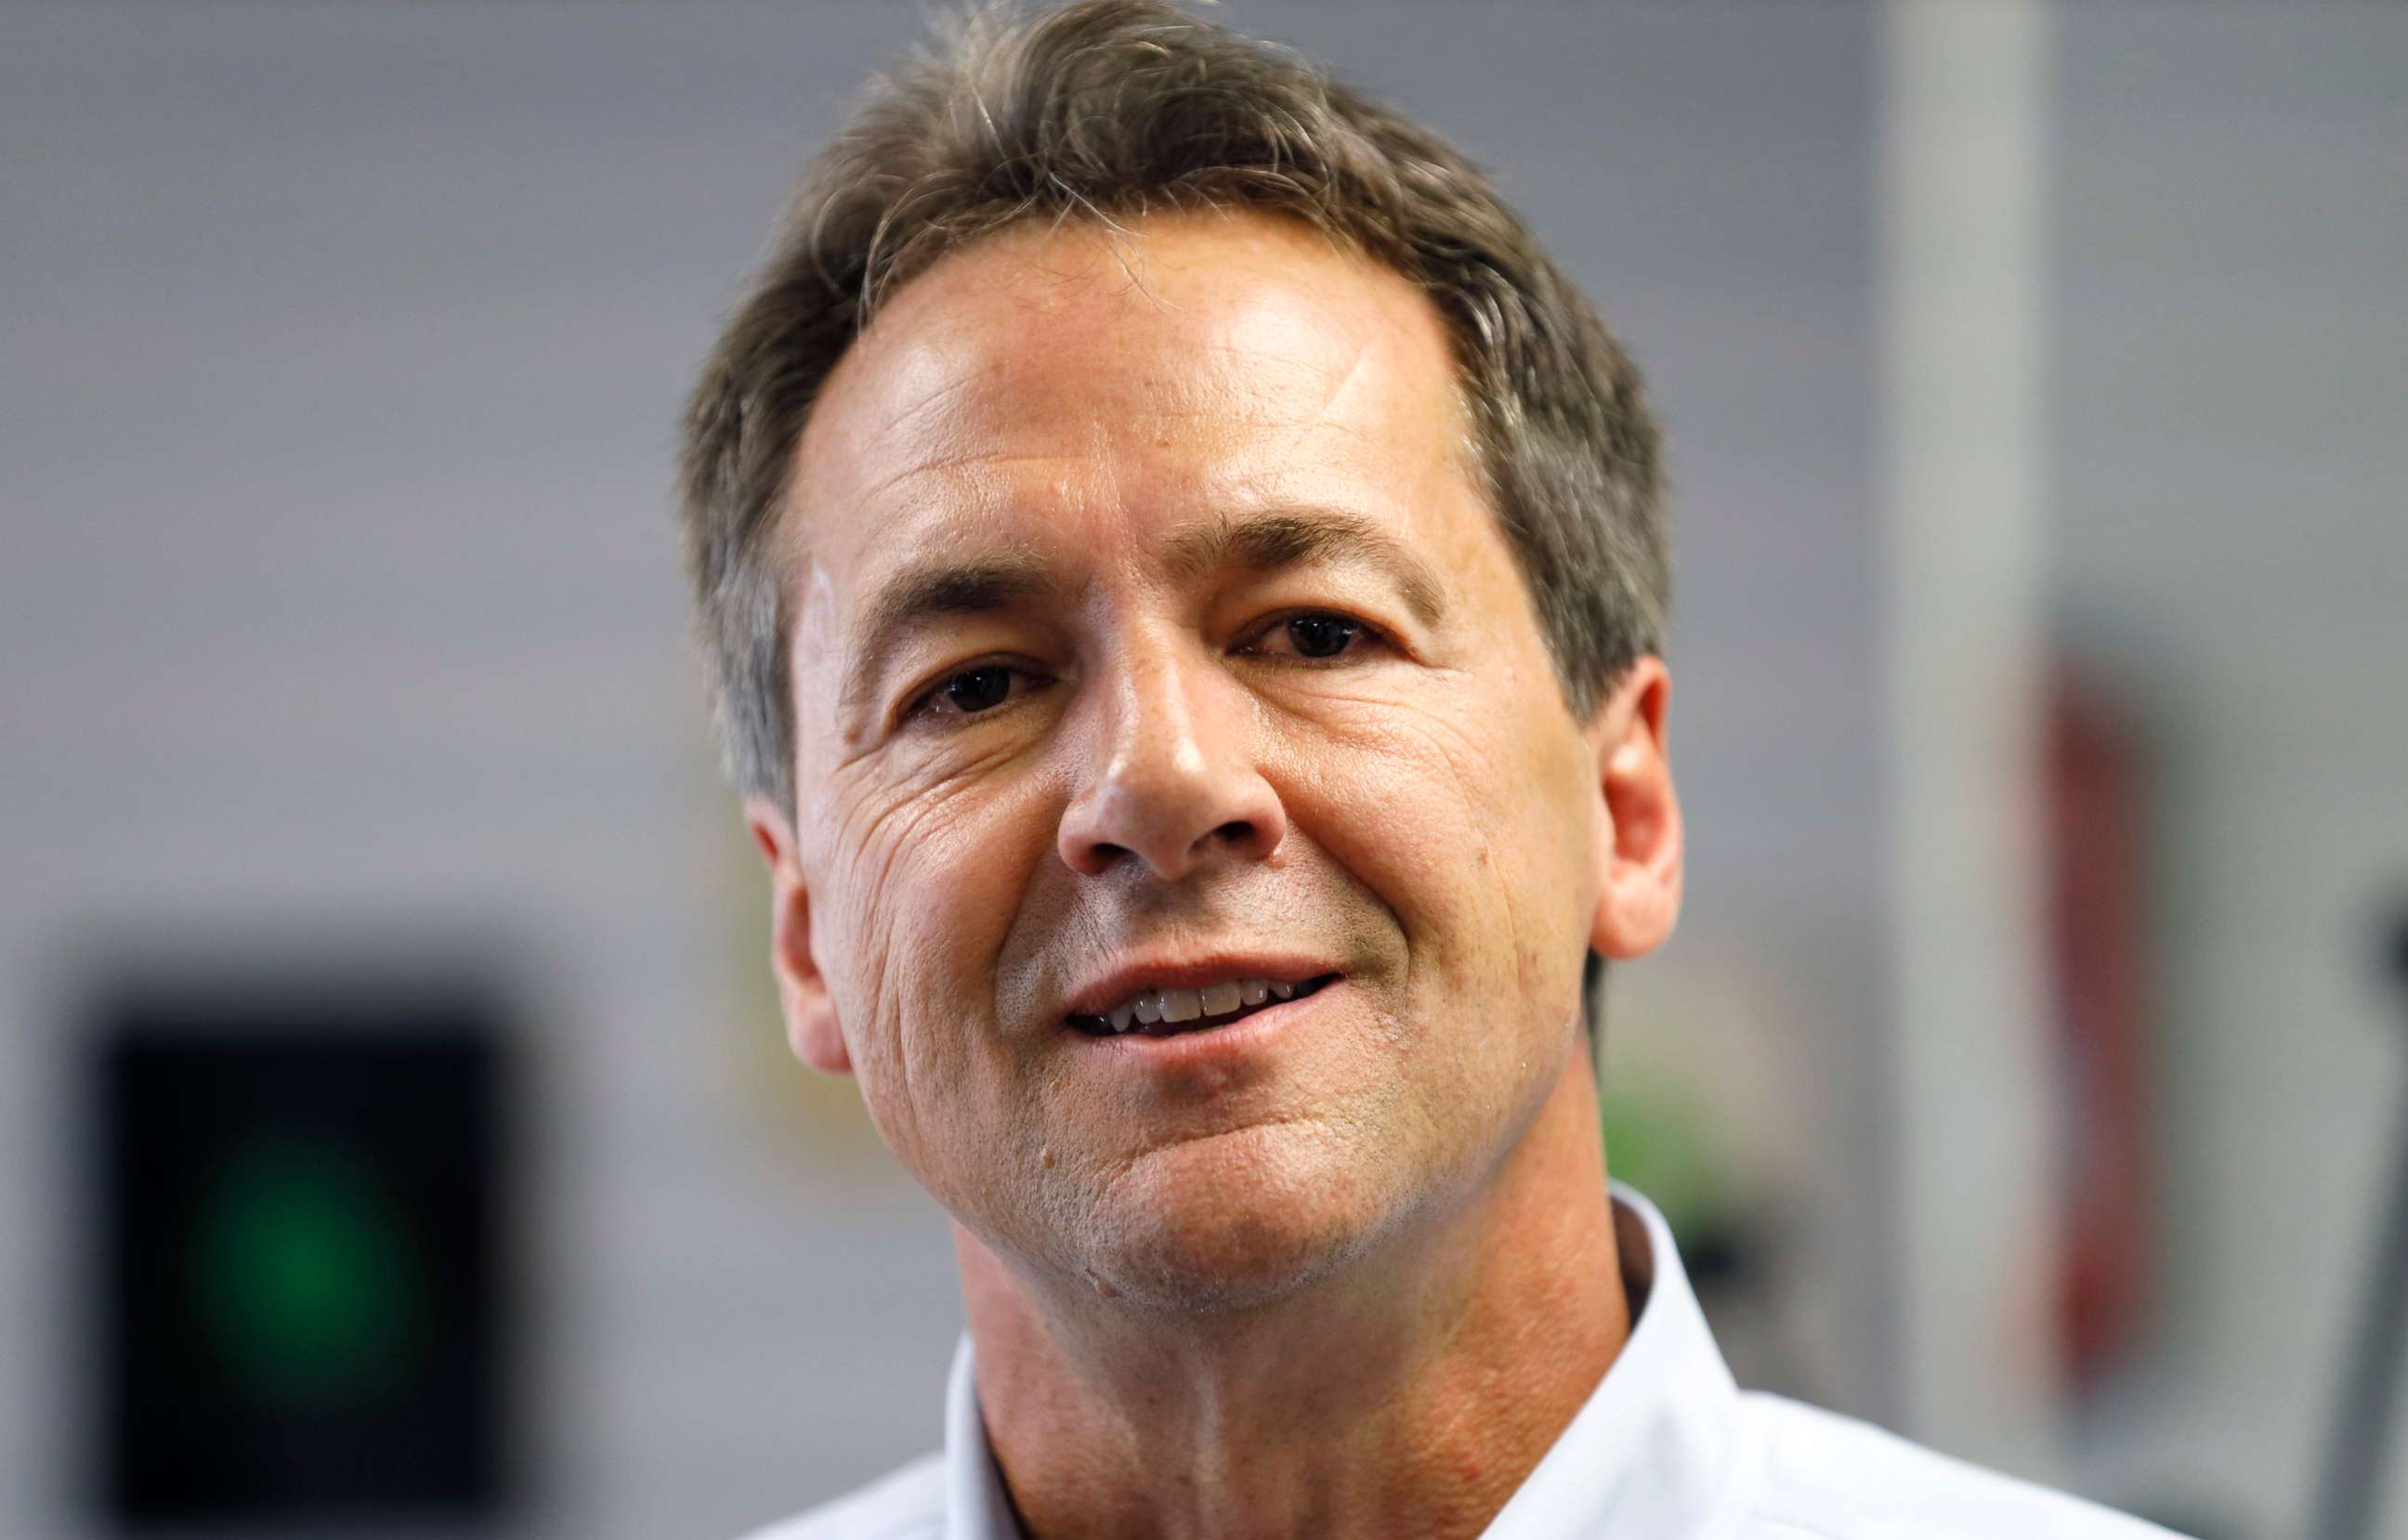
[1880,0,2059,1478]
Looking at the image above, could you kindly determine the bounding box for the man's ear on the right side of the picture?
[1587,655,1681,958]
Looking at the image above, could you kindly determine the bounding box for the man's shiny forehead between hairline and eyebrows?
[788,215,1469,596]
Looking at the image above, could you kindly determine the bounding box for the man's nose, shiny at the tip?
[1059,645,1289,881]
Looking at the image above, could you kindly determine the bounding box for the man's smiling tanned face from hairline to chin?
[753,216,1676,1307]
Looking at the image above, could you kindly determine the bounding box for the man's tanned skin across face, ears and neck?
[749,215,1681,1540]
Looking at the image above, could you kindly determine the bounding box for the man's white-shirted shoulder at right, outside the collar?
[1744,1390,2179,1540]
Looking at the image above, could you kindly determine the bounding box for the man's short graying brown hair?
[679,0,1669,816]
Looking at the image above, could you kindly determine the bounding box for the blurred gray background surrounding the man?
[0,0,2408,1540]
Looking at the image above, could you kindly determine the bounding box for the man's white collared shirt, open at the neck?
[749,1184,2172,1540]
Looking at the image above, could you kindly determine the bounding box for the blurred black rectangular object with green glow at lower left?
[97,989,508,1525]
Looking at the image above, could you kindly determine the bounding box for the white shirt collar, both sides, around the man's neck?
[944,1181,1738,1540]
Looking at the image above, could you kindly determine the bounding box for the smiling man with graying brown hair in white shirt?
[684,0,2186,1540]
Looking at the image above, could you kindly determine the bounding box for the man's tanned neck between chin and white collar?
[956,1054,1630,1540]
